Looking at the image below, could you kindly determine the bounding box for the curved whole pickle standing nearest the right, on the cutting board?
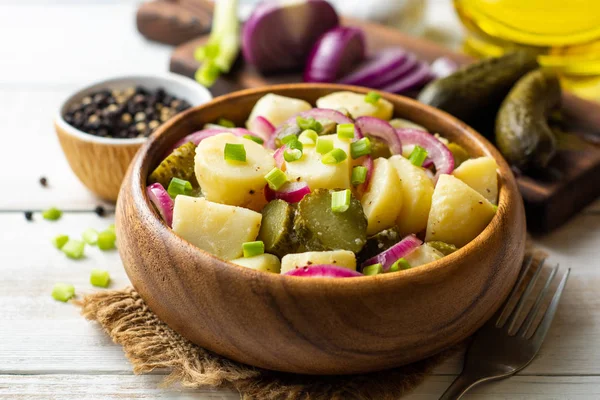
[496,70,561,169]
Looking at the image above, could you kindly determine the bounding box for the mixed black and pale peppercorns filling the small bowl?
[64,86,191,139]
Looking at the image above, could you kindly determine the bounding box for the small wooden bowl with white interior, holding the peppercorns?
[54,73,212,202]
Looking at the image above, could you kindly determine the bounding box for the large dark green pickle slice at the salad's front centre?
[294,189,367,253]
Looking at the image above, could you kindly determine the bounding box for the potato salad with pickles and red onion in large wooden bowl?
[147,92,498,277]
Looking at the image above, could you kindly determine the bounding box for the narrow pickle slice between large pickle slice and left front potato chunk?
[258,199,294,258]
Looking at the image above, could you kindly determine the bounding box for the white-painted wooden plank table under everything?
[0,0,600,400]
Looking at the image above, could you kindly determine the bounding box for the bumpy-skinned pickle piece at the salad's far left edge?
[148,142,198,189]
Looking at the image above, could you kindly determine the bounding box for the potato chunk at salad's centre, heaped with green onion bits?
[285,135,352,190]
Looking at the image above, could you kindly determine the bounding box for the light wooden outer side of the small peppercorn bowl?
[54,123,141,202]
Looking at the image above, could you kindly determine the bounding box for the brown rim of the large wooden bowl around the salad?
[127,83,521,293]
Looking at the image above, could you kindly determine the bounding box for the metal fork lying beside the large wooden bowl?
[440,257,571,400]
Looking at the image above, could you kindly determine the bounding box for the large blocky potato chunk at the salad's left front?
[173,195,262,260]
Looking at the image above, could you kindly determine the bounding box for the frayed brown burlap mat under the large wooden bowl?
[79,288,455,400]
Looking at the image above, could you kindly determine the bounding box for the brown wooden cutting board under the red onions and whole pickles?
[138,0,600,233]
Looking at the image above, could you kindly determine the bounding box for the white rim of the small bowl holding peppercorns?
[54,72,213,146]
